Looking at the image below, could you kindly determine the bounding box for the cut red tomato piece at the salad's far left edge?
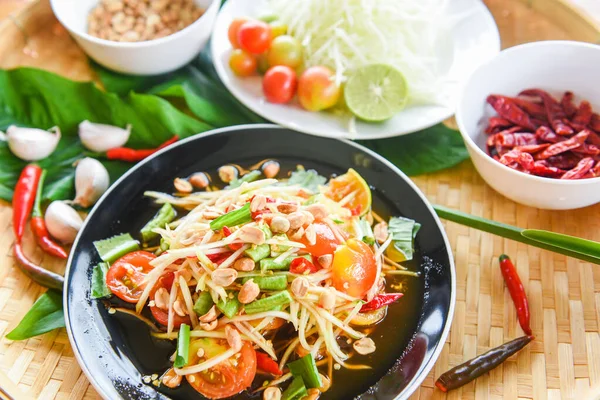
[106,251,156,303]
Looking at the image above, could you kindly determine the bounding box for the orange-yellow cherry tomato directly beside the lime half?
[298,66,340,111]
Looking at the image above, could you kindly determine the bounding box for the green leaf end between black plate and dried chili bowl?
[359,124,469,176]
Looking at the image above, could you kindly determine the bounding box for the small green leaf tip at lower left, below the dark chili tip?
[6,290,65,340]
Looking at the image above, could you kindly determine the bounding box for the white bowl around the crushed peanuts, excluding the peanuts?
[50,0,221,75]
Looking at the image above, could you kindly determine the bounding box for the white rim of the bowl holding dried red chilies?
[456,40,600,186]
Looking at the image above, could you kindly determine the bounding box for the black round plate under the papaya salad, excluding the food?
[64,125,455,399]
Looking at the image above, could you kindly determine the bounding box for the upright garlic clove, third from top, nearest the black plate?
[73,157,110,208]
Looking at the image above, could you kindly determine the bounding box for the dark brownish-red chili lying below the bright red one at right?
[435,335,534,393]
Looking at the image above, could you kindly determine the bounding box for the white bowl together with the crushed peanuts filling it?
[50,0,221,75]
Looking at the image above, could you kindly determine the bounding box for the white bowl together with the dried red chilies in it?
[456,41,600,210]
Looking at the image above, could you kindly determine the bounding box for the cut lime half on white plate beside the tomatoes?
[344,64,408,122]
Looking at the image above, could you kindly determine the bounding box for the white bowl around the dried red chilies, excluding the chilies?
[456,41,600,210]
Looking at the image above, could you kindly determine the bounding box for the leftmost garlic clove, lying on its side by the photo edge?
[0,125,60,161]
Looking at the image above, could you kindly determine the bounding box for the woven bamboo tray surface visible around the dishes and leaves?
[0,0,600,399]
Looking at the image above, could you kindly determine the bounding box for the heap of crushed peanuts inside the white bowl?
[88,0,204,42]
